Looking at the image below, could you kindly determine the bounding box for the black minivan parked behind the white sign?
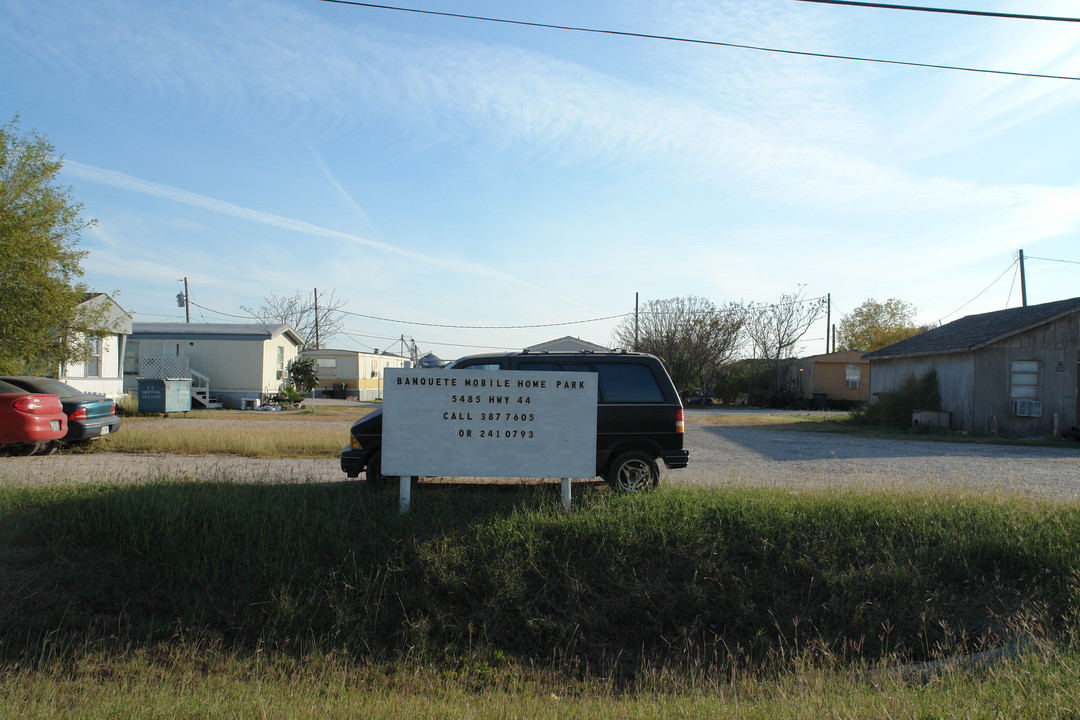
[341,351,689,492]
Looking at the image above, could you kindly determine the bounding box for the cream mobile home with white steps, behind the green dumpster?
[124,323,303,407]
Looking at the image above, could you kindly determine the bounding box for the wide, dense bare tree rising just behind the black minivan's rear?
[612,295,743,390]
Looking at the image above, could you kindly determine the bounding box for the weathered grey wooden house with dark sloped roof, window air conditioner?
[864,298,1080,437]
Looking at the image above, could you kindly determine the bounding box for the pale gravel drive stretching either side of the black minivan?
[0,412,1080,502]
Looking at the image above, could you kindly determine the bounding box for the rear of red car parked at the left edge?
[0,380,67,456]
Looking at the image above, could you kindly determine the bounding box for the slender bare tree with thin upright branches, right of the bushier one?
[745,285,827,399]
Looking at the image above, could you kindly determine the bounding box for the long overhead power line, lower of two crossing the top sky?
[319,0,1080,80]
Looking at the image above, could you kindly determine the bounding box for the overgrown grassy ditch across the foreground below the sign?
[0,481,1080,719]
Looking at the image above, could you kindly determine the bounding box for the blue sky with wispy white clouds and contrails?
[0,0,1080,357]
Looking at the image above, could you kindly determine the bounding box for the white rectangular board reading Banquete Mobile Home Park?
[382,368,597,478]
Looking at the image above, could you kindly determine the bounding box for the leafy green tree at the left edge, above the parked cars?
[0,116,106,373]
